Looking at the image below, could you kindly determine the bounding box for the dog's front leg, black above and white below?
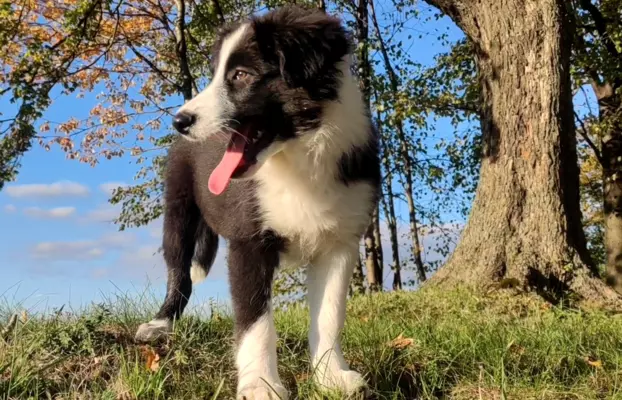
[229,237,287,400]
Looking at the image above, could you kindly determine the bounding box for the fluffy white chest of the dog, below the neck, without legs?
[257,156,373,261]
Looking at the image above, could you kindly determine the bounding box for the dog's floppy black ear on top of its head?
[254,6,351,87]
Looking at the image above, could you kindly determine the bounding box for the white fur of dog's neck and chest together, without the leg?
[255,58,373,266]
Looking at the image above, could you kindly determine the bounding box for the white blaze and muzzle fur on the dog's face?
[179,24,248,139]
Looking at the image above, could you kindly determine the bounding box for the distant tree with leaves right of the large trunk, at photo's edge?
[569,0,622,293]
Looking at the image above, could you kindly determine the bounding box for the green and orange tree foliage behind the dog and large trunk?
[0,0,622,298]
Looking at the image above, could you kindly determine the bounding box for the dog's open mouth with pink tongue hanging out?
[208,123,270,195]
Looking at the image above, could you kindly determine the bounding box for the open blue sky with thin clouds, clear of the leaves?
[0,3,468,311]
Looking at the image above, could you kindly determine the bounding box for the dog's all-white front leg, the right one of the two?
[307,246,366,395]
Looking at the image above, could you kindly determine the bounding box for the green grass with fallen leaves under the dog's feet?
[0,290,622,400]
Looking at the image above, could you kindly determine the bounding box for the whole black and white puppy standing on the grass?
[136,6,380,400]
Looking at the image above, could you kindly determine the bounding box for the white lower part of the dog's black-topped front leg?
[236,310,287,400]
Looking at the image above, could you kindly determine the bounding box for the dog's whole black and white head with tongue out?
[174,6,350,194]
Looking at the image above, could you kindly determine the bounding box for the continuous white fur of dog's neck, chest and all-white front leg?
[255,57,374,394]
